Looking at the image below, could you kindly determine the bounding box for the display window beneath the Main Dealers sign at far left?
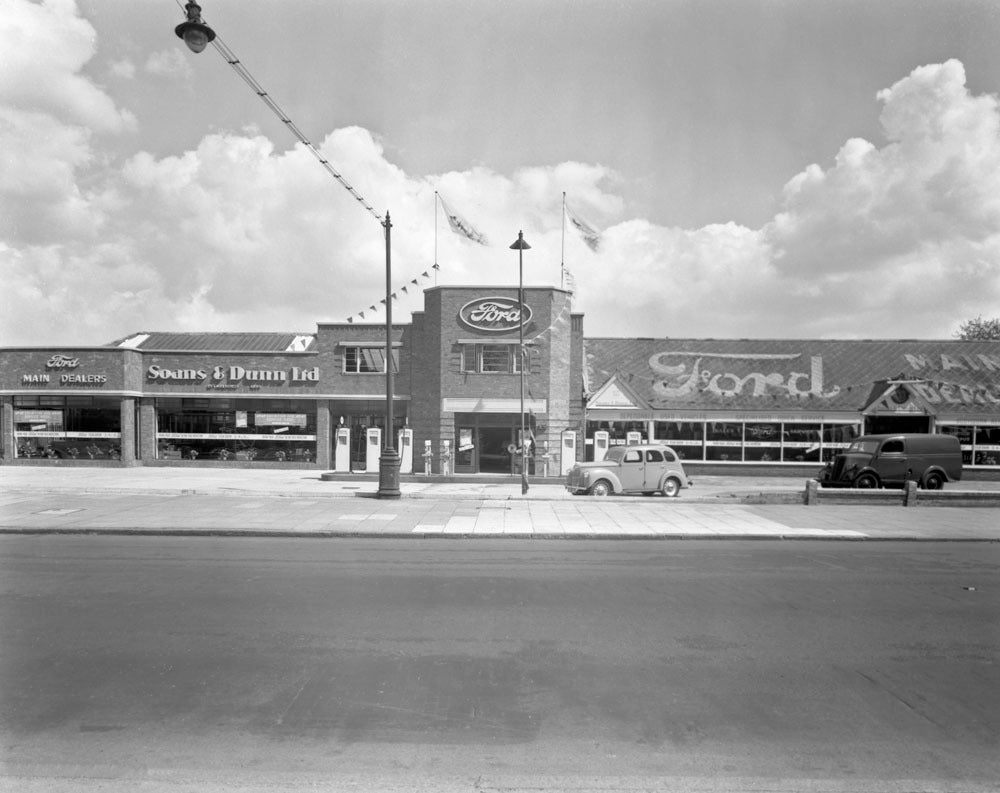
[14,394,122,460]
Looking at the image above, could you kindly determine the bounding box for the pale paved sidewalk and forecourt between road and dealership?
[0,466,1000,541]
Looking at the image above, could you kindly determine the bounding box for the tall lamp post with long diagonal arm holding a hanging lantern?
[174,0,400,498]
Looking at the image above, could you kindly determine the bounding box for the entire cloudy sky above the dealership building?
[0,0,1000,347]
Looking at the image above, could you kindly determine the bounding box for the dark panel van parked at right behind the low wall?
[818,433,962,490]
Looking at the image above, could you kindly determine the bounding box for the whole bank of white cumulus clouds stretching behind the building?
[0,0,1000,345]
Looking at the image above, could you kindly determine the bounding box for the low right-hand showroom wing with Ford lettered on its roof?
[585,339,1000,467]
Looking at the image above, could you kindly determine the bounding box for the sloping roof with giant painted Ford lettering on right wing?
[584,338,1000,414]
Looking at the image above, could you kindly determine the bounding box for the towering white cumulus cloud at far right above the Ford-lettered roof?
[764,60,1000,335]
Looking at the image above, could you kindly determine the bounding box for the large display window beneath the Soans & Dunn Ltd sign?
[156,398,316,463]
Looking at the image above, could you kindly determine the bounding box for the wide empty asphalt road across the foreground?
[0,535,1000,793]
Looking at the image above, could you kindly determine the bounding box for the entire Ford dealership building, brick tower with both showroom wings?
[0,286,1000,476]
